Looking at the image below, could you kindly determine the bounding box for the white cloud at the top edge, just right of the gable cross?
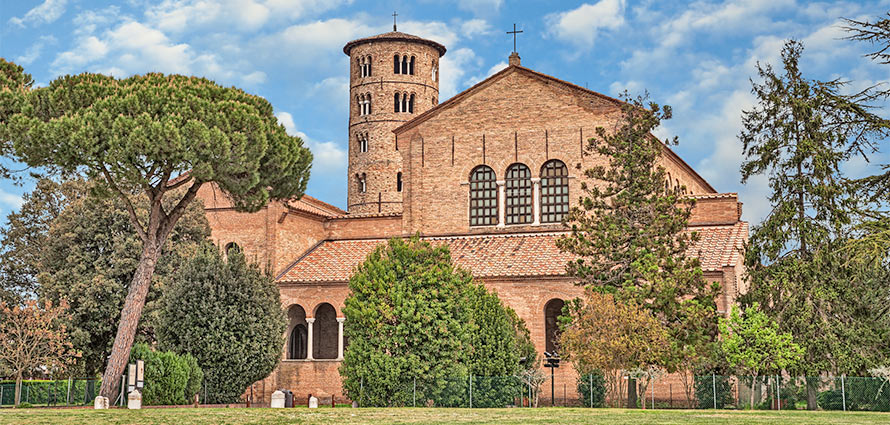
[544,0,624,48]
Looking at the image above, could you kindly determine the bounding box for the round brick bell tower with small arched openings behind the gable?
[343,25,445,214]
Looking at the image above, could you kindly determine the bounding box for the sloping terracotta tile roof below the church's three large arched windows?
[278,222,748,283]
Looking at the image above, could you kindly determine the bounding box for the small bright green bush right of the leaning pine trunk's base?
[130,343,203,406]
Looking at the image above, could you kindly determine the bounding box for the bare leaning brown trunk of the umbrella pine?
[99,241,160,401]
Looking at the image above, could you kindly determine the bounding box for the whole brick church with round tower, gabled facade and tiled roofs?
[199,27,748,403]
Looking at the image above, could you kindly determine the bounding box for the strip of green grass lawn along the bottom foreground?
[0,408,890,425]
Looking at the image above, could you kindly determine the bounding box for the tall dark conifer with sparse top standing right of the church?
[739,40,890,409]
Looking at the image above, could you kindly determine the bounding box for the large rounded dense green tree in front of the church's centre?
[340,237,535,406]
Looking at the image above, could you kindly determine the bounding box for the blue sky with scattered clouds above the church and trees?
[0,0,890,223]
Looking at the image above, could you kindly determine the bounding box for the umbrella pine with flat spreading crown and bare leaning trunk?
[0,58,312,397]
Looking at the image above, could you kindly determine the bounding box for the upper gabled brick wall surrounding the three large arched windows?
[397,71,709,234]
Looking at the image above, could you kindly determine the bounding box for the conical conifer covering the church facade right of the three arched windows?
[557,94,720,403]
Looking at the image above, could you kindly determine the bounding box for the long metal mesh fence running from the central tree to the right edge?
[349,373,890,412]
